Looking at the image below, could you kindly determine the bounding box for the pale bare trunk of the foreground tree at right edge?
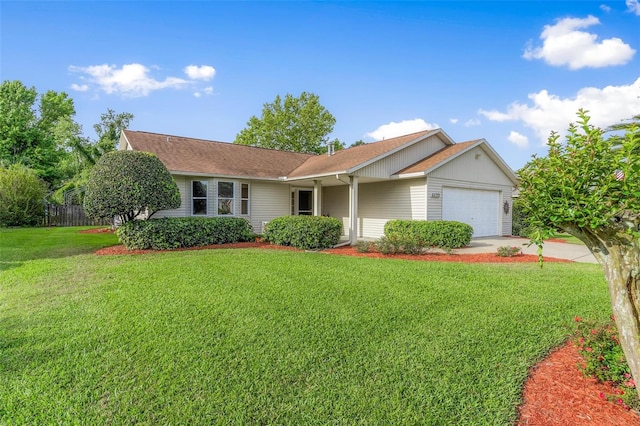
[566,227,640,395]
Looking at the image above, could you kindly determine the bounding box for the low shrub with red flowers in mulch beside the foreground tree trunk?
[574,317,640,410]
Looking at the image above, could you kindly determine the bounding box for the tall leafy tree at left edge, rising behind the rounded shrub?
[0,80,75,186]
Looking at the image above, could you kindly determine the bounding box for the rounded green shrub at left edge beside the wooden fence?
[0,164,47,226]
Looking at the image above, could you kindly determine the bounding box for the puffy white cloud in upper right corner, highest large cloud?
[523,15,636,70]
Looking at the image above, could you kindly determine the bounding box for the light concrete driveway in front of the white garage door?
[455,237,598,263]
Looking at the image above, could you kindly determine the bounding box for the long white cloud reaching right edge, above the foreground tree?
[478,78,640,143]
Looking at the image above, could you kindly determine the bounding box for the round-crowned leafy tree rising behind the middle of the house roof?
[234,92,336,154]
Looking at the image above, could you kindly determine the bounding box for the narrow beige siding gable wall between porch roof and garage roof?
[357,136,445,178]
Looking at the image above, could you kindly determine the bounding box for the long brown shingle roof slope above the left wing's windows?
[124,130,318,179]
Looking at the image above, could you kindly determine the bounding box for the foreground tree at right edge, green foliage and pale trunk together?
[519,110,640,390]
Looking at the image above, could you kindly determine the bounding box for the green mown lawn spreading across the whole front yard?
[0,228,610,425]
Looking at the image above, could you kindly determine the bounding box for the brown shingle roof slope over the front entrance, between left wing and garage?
[287,129,438,178]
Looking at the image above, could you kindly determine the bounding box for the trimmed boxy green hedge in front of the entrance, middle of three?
[264,216,342,250]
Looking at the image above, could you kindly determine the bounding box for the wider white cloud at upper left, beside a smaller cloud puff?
[69,64,188,97]
